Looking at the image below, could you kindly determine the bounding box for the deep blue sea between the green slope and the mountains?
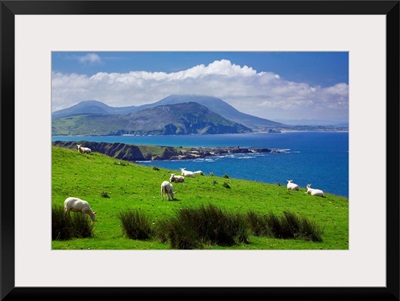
[52,132,349,197]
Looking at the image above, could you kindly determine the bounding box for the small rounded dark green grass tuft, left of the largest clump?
[119,209,152,240]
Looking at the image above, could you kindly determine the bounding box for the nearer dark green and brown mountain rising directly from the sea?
[52,102,251,136]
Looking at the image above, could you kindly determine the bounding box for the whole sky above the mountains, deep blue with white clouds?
[52,52,349,122]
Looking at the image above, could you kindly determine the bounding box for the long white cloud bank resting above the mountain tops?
[52,60,348,120]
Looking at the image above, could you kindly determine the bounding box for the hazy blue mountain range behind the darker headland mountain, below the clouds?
[52,95,285,129]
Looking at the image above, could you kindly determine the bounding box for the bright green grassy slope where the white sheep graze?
[52,146,349,250]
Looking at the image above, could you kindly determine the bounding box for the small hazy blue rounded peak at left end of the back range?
[52,100,138,119]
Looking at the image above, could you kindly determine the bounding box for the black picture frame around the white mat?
[0,1,400,301]
